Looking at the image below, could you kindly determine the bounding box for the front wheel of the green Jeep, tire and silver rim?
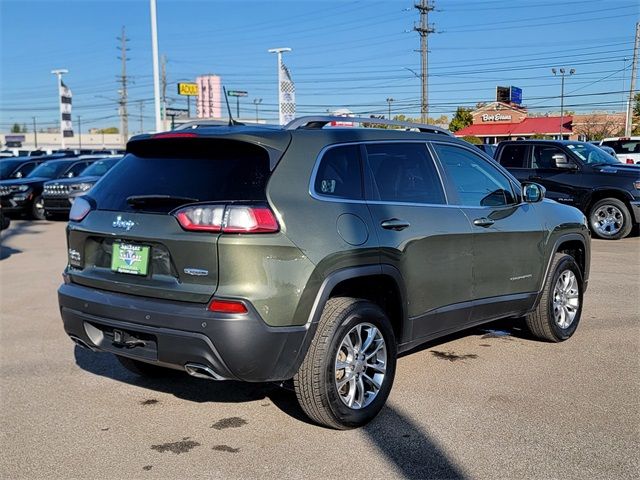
[526,253,583,342]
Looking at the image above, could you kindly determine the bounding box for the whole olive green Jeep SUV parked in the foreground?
[58,117,590,429]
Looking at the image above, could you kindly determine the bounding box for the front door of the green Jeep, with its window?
[432,142,543,320]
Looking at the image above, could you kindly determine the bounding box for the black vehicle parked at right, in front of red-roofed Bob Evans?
[494,140,640,240]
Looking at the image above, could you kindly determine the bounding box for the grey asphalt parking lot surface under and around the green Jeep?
[0,221,640,479]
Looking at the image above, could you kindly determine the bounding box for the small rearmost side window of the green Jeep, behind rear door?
[313,145,362,200]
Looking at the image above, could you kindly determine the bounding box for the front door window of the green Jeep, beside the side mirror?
[433,143,515,207]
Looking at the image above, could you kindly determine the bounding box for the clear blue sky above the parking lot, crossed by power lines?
[0,0,640,132]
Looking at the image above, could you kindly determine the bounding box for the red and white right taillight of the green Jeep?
[173,205,280,233]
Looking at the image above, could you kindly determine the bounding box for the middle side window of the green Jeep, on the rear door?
[366,143,446,204]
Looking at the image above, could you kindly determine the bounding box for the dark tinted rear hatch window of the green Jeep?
[90,139,270,212]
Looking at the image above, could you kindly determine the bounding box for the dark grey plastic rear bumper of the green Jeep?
[58,284,309,382]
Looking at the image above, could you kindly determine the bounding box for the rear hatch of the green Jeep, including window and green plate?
[68,138,284,303]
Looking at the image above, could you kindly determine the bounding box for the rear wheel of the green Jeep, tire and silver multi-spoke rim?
[293,297,397,430]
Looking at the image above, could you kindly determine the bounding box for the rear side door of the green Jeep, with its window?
[364,142,472,339]
